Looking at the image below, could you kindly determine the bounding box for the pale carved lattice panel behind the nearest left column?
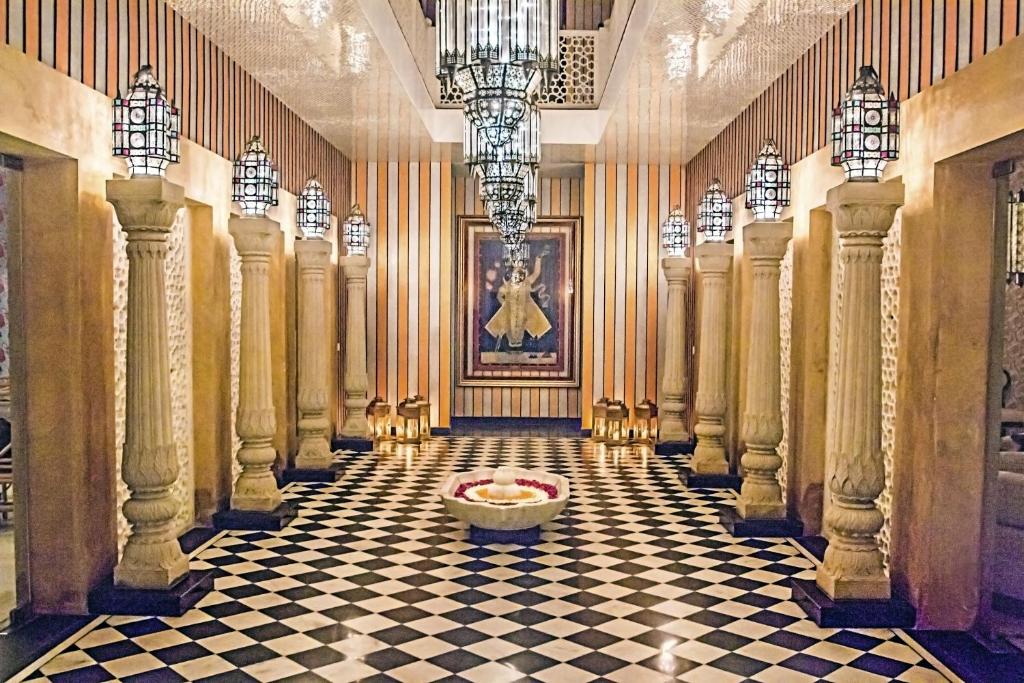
[113,210,196,554]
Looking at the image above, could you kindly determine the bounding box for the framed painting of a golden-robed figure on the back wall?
[456,216,581,387]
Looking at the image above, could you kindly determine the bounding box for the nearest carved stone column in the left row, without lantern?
[106,177,188,589]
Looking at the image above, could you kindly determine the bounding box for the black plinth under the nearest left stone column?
[89,569,216,616]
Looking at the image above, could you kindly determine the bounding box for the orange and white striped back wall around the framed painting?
[352,162,685,427]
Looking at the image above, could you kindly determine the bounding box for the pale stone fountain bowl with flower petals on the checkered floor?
[439,467,569,544]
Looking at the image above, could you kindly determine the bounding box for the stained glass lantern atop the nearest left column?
[114,65,181,176]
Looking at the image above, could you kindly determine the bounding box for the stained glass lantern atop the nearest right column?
[831,67,899,182]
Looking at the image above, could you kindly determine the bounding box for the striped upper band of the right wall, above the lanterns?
[686,0,1024,211]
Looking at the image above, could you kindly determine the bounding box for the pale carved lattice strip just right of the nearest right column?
[879,209,903,571]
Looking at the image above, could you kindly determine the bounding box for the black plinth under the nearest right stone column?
[790,579,918,629]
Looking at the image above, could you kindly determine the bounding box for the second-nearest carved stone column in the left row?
[228,217,282,512]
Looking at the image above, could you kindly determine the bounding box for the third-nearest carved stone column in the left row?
[295,240,334,470]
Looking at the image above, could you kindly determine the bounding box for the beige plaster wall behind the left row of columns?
[0,47,348,612]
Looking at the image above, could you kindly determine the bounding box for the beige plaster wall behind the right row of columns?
[731,38,1024,629]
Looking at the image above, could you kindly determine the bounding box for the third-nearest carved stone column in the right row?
[690,242,732,475]
